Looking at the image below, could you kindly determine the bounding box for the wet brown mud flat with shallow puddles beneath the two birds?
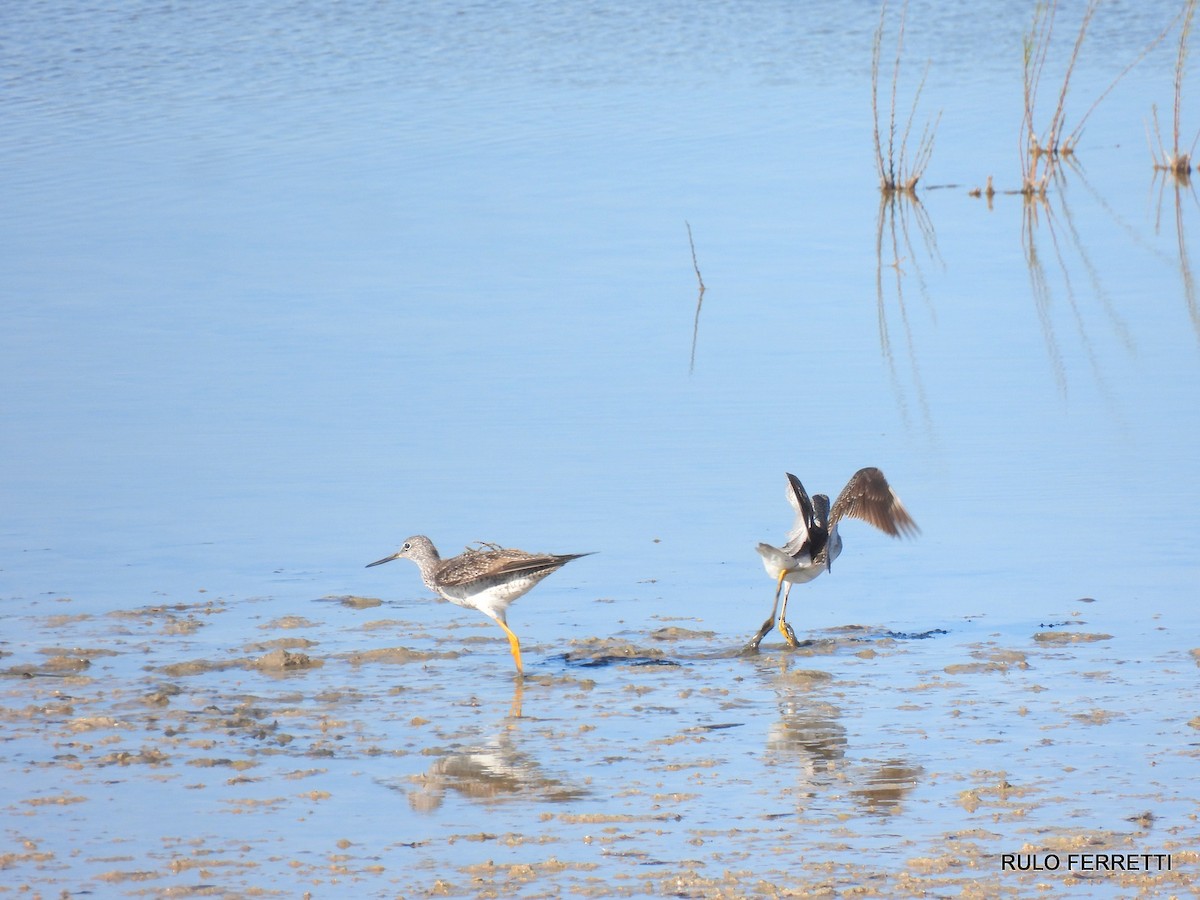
[0,598,1200,898]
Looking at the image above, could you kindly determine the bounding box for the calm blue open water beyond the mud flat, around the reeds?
[0,2,1200,897]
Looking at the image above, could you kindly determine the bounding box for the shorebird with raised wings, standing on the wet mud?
[745,468,920,652]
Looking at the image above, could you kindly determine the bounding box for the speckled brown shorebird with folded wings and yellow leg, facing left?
[367,534,592,674]
